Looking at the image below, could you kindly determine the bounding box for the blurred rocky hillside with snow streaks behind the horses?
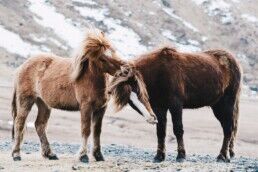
[0,0,258,96]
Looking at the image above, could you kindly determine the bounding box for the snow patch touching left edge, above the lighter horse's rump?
[0,25,40,57]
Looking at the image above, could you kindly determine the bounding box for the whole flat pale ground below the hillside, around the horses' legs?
[0,82,258,171]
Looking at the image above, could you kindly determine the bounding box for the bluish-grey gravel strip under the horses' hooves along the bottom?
[0,141,258,171]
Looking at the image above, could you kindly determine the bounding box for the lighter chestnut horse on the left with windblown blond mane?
[12,29,155,162]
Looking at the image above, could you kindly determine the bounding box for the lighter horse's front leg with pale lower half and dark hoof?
[79,103,93,163]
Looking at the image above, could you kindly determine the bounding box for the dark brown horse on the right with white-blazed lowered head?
[109,47,241,162]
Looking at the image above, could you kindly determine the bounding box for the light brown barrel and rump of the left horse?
[16,54,78,110]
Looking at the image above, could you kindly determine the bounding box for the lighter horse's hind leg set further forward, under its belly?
[35,99,58,160]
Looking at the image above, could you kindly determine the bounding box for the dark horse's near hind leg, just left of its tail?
[212,95,235,162]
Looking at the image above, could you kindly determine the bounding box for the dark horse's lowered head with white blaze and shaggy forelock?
[107,65,157,124]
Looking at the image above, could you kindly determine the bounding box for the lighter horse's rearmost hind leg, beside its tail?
[12,96,34,161]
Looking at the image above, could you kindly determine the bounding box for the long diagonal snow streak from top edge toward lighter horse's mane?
[29,0,82,48]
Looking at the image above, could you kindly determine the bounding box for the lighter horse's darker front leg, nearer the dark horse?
[92,107,106,161]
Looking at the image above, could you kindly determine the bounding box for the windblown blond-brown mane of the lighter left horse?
[72,29,114,81]
